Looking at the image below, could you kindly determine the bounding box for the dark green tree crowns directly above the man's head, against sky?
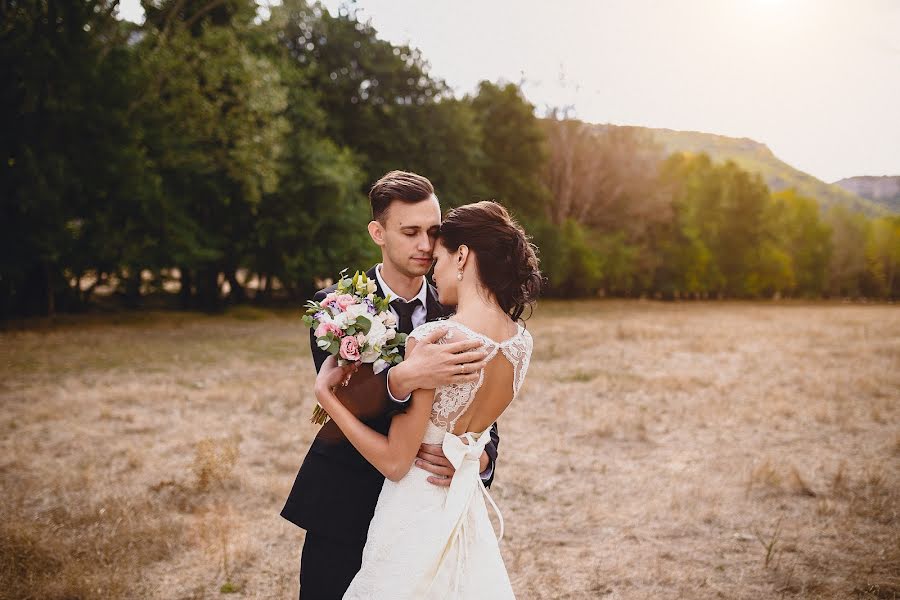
[280,0,481,205]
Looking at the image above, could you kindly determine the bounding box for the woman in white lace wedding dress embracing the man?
[316,201,541,598]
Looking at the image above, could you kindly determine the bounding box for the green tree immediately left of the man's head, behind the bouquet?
[246,0,374,300]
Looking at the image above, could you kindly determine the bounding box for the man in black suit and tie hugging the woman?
[281,171,500,600]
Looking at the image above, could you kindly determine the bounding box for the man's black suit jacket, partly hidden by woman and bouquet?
[281,267,500,543]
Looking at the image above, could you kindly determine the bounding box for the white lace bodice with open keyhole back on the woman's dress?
[410,320,532,432]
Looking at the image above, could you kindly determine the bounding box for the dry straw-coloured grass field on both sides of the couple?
[0,300,900,600]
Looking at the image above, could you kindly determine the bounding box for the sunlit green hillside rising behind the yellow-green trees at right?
[600,126,898,216]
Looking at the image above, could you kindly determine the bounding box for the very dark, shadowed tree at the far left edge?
[0,0,158,315]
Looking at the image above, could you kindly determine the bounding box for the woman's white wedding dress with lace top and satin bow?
[344,320,533,600]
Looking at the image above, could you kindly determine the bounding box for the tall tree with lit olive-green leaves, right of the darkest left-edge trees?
[133,0,289,310]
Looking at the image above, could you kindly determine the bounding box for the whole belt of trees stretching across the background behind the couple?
[0,0,900,318]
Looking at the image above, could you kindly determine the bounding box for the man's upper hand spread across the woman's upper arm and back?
[388,327,487,398]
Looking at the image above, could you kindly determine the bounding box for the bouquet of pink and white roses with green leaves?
[303,269,406,425]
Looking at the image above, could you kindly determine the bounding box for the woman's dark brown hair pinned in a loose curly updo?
[438,200,543,321]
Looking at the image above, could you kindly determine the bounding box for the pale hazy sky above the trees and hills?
[119,0,900,182]
